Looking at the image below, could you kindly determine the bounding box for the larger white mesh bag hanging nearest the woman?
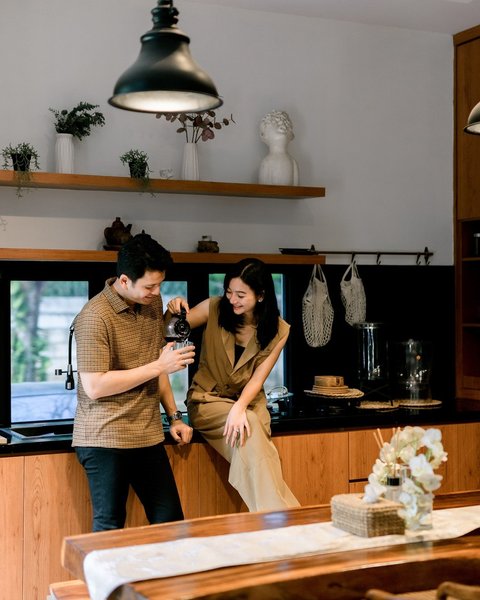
[302,265,333,348]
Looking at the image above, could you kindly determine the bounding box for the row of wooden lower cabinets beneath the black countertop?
[0,423,480,600]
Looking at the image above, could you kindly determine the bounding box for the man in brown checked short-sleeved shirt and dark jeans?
[73,233,195,531]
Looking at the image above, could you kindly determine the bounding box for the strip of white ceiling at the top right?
[192,0,480,34]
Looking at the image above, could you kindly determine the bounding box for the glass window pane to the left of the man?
[10,281,88,423]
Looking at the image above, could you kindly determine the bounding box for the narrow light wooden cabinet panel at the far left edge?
[0,456,24,600]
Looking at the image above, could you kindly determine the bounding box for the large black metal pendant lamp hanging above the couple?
[108,0,223,113]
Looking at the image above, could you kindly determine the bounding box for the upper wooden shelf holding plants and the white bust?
[0,171,325,200]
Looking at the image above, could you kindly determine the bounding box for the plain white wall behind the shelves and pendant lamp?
[0,0,453,265]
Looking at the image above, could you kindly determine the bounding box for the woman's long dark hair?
[218,258,280,350]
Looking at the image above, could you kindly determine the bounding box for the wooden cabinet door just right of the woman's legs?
[273,432,348,506]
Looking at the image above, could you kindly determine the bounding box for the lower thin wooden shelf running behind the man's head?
[0,248,325,265]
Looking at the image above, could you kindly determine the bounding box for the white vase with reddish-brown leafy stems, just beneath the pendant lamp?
[156,110,235,180]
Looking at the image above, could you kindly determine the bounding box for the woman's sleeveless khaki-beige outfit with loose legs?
[187,298,299,511]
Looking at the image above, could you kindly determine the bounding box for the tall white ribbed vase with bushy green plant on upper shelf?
[49,101,105,173]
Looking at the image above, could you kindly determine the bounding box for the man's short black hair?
[117,231,173,283]
